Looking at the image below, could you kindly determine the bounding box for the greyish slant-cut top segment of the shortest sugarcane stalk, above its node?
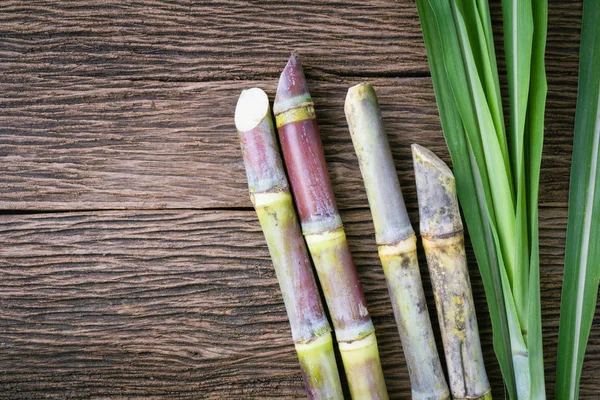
[412,144,463,237]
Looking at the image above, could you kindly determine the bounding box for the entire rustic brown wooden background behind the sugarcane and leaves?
[0,0,600,399]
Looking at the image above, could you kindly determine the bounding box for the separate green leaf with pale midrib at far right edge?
[556,0,600,400]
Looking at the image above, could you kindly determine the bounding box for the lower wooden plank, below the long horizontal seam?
[0,208,600,399]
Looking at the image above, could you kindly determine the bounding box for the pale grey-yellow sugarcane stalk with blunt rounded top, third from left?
[344,83,450,400]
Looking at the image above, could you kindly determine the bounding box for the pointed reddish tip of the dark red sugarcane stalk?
[273,53,312,115]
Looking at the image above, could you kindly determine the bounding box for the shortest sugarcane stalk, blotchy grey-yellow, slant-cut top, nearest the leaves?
[412,144,492,400]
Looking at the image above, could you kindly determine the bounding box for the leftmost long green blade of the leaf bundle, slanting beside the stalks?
[416,0,517,399]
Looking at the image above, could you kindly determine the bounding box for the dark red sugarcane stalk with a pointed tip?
[273,54,388,400]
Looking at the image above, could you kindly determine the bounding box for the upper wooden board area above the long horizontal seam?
[0,0,580,210]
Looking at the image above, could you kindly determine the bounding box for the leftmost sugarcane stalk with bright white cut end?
[235,88,343,399]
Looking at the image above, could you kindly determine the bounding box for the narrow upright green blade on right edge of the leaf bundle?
[524,0,548,399]
